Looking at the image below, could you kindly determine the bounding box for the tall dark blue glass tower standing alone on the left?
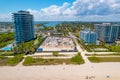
[13,11,34,43]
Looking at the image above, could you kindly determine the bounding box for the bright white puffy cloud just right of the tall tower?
[28,2,75,21]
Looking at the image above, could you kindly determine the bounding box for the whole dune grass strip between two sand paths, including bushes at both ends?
[23,54,84,66]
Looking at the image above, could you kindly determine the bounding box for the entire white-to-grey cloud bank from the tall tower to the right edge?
[0,0,120,21]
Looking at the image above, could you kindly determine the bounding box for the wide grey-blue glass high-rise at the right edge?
[94,23,119,43]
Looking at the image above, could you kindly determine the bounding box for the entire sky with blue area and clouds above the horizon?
[0,0,120,21]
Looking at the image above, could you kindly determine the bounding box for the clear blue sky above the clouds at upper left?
[0,0,74,14]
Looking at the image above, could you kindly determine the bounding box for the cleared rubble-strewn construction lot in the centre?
[37,36,76,52]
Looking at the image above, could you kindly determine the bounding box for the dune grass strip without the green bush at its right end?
[23,57,71,66]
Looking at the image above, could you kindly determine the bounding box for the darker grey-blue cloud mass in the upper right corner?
[71,0,120,16]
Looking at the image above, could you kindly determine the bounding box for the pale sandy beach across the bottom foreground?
[0,63,120,80]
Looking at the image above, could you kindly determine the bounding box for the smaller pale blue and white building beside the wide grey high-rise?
[80,30,98,44]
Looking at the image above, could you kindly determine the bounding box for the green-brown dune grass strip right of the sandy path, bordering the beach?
[88,56,120,63]
